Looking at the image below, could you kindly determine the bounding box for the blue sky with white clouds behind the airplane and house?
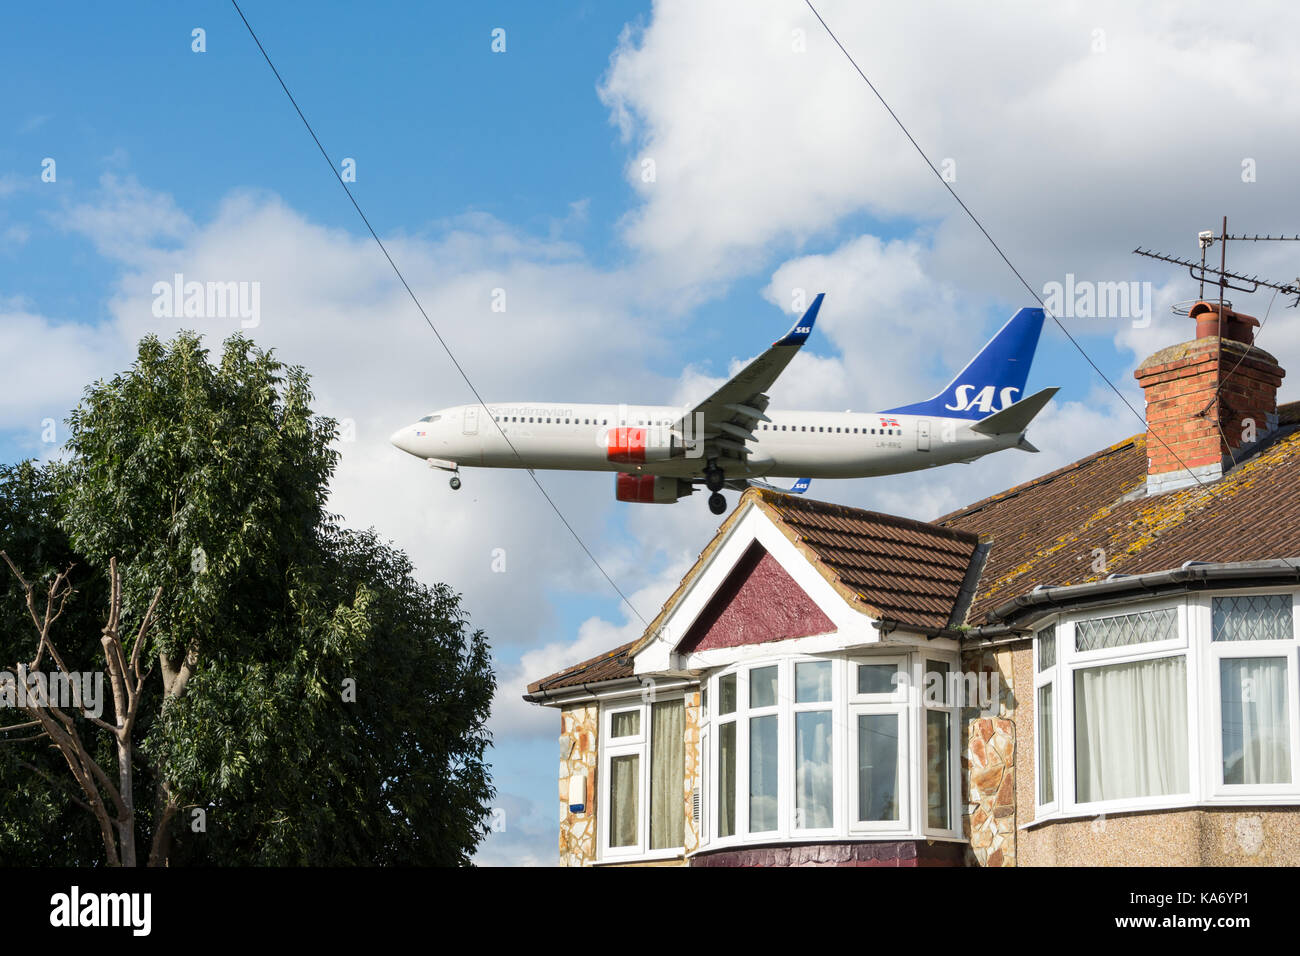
[0,0,1300,864]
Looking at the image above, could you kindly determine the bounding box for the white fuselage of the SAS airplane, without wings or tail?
[393,402,1019,479]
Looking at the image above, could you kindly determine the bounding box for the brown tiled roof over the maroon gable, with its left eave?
[528,488,979,696]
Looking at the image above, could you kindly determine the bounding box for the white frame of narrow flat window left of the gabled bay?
[595,691,685,862]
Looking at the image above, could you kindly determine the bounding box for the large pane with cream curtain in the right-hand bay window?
[1074,656,1187,803]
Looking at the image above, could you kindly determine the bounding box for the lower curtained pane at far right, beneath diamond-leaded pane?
[1219,658,1291,783]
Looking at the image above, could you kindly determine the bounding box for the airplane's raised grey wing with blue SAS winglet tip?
[677,293,826,462]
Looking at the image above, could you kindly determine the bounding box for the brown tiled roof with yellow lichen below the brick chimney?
[935,403,1300,624]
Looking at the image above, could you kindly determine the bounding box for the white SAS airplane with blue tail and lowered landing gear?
[390,293,1058,515]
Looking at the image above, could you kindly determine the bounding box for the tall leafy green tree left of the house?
[0,334,494,865]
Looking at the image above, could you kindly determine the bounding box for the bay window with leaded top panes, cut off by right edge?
[1034,592,1300,819]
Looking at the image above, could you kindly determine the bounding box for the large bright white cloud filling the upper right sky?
[599,0,1300,299]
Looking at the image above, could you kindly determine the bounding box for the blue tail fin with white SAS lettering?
[884,308,1044,420]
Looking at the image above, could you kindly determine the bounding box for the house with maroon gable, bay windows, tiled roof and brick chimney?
[527,302,1300,866]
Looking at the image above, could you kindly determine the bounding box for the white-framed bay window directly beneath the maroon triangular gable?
[701,649,959,845]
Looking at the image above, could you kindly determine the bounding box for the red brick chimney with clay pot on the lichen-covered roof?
[1134,302,1286,494]
